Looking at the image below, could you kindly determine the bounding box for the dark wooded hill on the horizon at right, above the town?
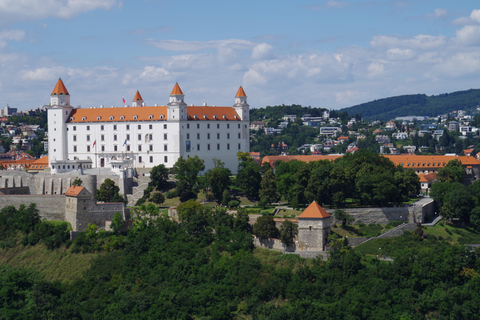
[339,89,480,120]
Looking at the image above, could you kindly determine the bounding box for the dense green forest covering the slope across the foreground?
[0,201,480,320]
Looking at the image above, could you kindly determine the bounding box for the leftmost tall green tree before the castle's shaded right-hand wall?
[173,155,205,202]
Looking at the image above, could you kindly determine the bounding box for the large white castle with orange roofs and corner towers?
[48,80,250,173]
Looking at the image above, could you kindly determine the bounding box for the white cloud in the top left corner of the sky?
[0,0,117,23]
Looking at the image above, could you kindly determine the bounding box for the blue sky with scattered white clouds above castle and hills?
[0,0,480,110]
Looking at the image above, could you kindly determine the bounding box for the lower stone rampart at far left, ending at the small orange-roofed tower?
[0,195,65,221]
